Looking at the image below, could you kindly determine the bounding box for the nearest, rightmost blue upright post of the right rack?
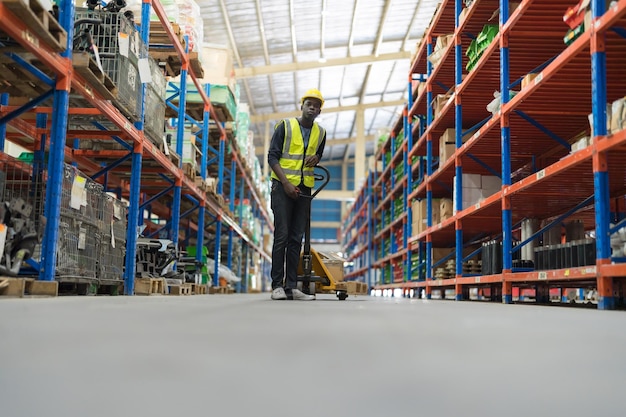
[591,0,615,310]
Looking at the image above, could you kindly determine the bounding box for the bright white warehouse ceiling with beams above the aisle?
[197,0,438,161]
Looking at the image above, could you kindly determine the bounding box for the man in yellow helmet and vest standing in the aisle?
[267,89,326,301]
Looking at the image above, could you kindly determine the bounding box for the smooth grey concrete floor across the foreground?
[0,294,626,417]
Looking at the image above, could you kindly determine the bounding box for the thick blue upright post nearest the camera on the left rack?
[39,0,74,281]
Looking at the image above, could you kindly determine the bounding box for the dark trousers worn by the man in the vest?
[271,180,311,292]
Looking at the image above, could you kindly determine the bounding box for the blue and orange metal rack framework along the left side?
[0,1,272,294]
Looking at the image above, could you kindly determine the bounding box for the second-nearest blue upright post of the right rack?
[500,0,513,304]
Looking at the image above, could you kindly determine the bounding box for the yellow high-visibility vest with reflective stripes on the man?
[272,118,324,188]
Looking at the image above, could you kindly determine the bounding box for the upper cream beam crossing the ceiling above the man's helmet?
[235,51,411,79]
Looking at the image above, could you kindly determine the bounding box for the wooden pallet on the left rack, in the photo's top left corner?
[2,0,67,52]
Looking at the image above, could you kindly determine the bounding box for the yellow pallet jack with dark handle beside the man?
[297,165,348,300]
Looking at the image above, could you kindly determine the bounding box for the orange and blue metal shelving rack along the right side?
[344,0,626,309]
